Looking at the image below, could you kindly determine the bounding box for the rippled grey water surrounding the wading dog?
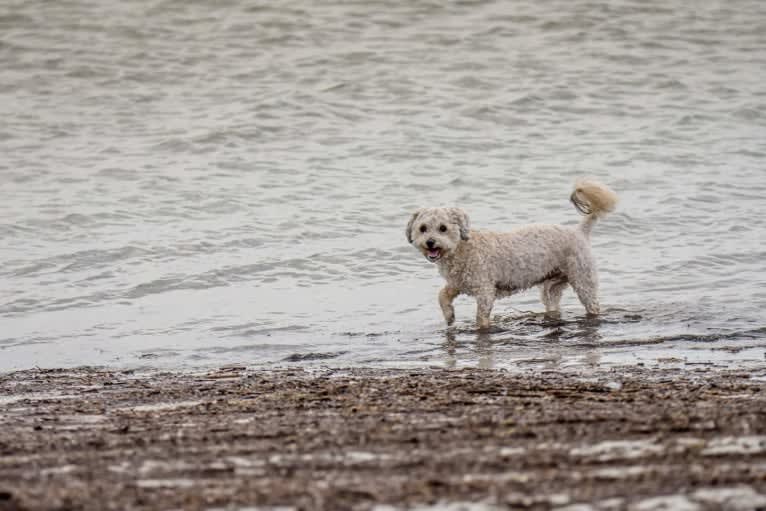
[0,0,766,370]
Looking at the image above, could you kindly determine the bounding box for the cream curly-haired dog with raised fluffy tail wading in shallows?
[406,179,617,329]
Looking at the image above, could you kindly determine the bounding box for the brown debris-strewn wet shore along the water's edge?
[0,367,766,511]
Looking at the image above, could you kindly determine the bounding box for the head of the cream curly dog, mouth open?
[405,208,470,263]
